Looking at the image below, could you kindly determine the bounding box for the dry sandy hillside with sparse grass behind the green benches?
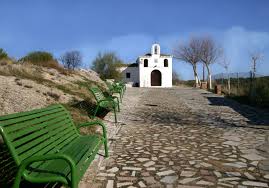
[0,64,105,123]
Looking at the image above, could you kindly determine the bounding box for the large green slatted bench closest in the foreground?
[0,105,108,188]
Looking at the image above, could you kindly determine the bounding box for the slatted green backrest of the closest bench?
[0,105,79,165]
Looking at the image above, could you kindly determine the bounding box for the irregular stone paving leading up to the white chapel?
[80,88,269,188]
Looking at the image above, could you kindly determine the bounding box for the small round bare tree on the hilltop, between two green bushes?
[60,50,82,70]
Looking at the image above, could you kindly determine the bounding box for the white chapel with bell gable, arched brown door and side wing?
[120,44,172,87]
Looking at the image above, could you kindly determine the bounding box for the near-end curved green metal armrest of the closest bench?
[13,153,78,188]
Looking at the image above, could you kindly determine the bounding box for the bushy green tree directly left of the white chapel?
[92,52,123,79]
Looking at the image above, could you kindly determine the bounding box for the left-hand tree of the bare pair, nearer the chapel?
[174,38,201,87]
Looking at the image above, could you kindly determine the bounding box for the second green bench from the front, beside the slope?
[90,86,120,123]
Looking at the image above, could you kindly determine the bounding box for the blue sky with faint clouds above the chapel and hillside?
[0,0,269,79]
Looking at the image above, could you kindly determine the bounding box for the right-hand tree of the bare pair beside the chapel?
[200,37,222,89]
